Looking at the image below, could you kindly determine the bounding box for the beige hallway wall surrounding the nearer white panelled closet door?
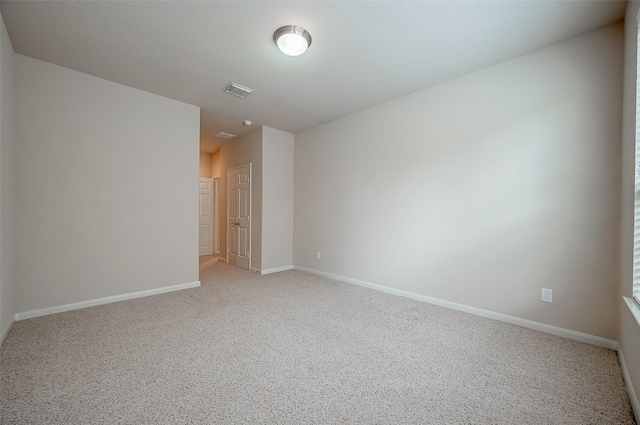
[218,127,262,270]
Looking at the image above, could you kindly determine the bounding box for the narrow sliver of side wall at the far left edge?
[0,13,16,344]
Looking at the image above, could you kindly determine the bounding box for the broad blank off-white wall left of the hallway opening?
[15,55,200,312]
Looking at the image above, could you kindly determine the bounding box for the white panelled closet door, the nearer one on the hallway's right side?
[227,164,251,269]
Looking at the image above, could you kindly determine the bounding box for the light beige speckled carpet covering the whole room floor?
[0,262,634,424]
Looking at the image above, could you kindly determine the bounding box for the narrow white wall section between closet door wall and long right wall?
[262,127,294,272]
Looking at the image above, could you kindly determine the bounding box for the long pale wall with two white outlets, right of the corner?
[294,24,623,339]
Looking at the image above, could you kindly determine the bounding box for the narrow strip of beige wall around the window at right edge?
[618,1,640,419]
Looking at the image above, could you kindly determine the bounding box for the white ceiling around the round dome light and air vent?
[2,0,626,152]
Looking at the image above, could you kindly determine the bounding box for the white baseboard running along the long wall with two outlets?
[293,266,618,350]
